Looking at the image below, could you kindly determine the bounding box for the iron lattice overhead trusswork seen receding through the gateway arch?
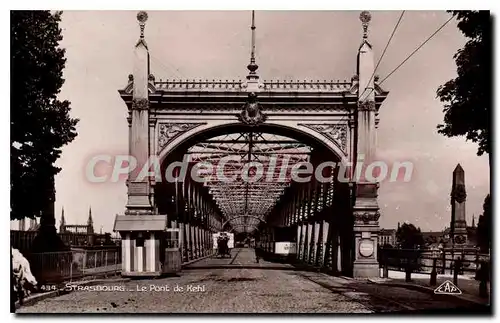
[187,132,312,232]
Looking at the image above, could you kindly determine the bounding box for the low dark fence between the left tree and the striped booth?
[27,249,121,284]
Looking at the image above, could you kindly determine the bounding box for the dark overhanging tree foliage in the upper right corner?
[437,11,492,164]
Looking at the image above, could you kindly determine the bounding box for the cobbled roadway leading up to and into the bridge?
[18,248,488,313]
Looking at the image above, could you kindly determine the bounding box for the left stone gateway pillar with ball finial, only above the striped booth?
[125,11,152,215]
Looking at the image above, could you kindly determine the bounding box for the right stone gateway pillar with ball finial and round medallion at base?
[351,11,380,278]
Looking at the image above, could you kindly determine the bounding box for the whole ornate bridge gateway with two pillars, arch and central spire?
[114,11,388,277]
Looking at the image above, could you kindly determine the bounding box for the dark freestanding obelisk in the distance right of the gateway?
[450,164,467,245]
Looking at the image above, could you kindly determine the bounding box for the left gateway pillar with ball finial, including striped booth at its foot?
[113,11,167,277]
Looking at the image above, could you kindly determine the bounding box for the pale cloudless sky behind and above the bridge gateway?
[11,11,490,232]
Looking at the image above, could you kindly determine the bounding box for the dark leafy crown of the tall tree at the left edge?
[10,11,78,219]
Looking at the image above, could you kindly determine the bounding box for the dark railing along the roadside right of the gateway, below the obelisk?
[378,248,490,275]
